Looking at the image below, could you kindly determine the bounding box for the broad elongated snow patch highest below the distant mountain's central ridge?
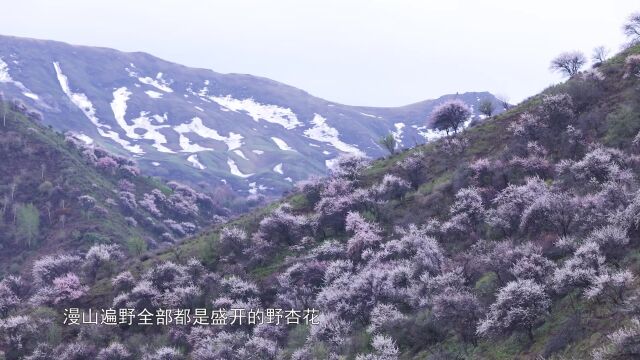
[208,95,303,130]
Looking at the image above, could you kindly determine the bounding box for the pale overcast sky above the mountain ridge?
[0,0,640,106]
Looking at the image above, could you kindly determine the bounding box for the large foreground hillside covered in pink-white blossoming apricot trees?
[0,46,640,360]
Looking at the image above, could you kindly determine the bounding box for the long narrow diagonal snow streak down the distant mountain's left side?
[53,62,144,155]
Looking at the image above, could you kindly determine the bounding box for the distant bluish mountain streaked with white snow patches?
[0,36,499,194]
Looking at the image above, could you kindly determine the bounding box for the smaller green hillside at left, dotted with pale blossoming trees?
[0,101,240,273]
